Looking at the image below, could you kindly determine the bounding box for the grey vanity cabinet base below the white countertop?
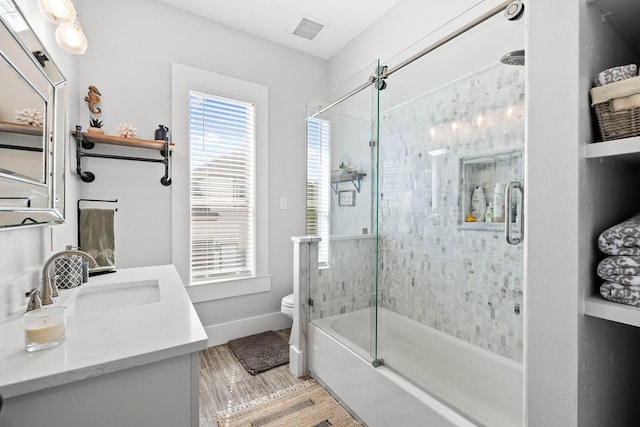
[0,353,199,427]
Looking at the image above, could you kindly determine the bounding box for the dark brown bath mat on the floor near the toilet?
[229,331,289,375]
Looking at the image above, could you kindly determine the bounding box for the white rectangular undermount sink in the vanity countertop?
[65,279,160,315]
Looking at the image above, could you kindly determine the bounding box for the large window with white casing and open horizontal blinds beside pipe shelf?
[170,63,271,303]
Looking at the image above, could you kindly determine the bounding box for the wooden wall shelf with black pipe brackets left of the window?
[71,126,174,186]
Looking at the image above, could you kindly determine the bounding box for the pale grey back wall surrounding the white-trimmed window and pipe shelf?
[72,0,327,338]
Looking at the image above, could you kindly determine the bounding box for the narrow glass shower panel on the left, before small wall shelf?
[306,62,379,361]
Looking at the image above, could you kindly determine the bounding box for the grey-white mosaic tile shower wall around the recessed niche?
[380,65,524,362]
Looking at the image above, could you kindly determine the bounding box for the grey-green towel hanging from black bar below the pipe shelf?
[79,209,116,270]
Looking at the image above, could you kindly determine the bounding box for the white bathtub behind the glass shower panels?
[309,309,523,427]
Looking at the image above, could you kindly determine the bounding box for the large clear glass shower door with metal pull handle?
[377,9,525,426]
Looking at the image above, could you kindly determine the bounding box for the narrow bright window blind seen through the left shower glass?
[306,118,331,266]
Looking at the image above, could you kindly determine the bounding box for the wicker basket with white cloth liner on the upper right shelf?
[591,77,640,141]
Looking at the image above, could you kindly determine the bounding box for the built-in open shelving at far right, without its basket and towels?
[576,0,640,426]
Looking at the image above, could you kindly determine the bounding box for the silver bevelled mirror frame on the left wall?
[0,0,68,230]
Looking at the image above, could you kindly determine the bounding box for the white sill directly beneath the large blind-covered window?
[185,276,271,304]
